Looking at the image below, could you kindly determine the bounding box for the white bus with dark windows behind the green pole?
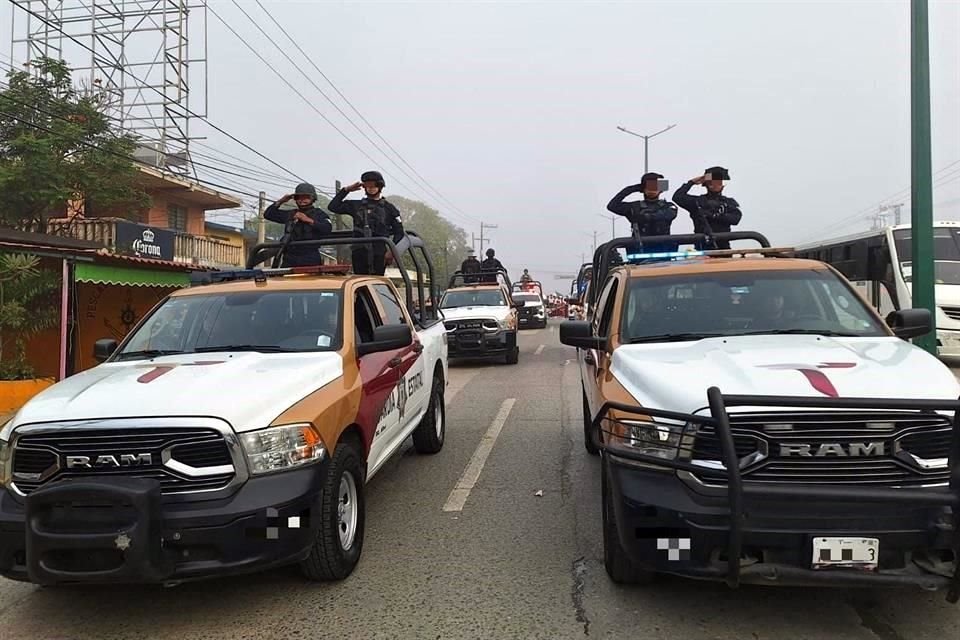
[797,222,960,357]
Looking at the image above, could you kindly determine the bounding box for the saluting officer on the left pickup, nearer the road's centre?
[327,171,405,276]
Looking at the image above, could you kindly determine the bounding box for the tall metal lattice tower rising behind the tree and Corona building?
[11,0,207,173]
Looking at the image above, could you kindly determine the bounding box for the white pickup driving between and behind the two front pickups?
[440,270,525,364]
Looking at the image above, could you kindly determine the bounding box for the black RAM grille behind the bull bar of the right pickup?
[689,411,953,486]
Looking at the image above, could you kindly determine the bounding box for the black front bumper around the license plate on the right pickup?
[604,452,956,590]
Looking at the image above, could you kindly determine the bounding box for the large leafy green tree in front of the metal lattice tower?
[0,58,150,231]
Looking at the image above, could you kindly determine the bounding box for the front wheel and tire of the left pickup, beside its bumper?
[300,439,366,581]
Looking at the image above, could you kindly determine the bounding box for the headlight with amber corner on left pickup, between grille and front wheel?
[240,422,326,475]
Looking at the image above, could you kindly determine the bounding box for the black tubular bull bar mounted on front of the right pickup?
[592,387,960,603]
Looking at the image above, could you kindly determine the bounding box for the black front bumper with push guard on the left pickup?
[0,460,328,585]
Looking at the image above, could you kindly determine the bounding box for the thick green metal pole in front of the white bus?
[910,0,937,355]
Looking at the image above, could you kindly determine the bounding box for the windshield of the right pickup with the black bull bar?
[622,270,889,342]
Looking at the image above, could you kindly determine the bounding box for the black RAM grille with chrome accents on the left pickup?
[12,424,237,495]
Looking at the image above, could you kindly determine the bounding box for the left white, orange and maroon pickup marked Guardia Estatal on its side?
[0,233,448,585]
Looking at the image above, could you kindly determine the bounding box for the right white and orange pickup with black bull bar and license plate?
[560,231,960,602]
